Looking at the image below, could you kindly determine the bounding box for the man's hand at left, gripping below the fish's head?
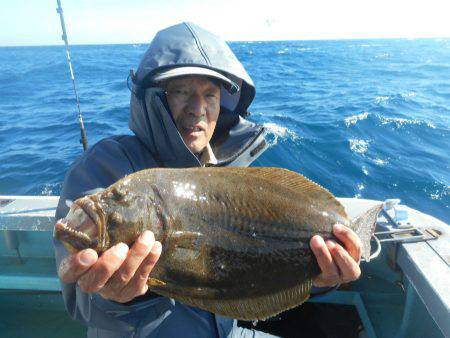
[58,231,161,303]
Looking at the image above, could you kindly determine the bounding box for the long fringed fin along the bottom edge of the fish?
[161,279,312,320]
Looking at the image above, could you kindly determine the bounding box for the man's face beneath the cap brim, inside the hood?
[166,76,220,154]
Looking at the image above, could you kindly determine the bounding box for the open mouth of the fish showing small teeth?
[54,198,104,253]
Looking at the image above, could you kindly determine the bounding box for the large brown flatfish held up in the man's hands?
[55,168,382,320]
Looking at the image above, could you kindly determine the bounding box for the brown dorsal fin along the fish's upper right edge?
[226,167,348,219]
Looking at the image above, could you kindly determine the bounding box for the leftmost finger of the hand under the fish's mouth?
[58,249,98,283]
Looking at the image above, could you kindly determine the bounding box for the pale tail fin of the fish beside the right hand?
[351,203,383,262]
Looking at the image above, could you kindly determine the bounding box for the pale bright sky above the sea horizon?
[0,0,450,46]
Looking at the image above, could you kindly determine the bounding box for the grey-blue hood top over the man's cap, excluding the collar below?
[133,22,255,116]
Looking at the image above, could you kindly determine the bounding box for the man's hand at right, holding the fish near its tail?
[310,224,361,287]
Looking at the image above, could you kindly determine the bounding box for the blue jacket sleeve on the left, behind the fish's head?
[54,139,174,332]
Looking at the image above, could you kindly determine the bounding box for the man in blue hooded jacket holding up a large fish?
[55,23,360,337]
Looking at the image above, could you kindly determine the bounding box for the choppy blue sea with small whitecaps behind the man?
[0,39,450,223]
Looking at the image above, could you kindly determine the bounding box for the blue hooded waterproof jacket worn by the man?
[54,23,267,338]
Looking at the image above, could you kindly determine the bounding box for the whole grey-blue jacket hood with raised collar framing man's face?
[129,23,262,167]
